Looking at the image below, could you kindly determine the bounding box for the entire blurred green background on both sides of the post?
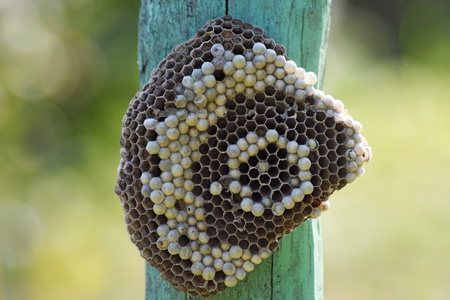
[0,0,450,300]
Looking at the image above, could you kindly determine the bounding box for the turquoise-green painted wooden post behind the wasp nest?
[138,0,331,300]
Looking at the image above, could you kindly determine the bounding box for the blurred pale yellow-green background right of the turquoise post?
[322,1,450,300]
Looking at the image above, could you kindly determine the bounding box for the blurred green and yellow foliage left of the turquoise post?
[0,0,144,300]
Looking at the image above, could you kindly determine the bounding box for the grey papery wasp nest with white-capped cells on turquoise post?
[116,16,370,297]
